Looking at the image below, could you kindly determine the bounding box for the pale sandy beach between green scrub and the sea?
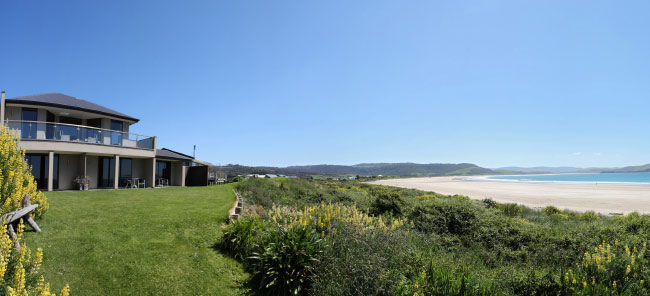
[370,177,650,214]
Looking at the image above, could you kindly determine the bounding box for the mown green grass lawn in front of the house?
[25,185,248,295]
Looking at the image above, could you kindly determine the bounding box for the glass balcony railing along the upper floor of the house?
[7,120,154,149]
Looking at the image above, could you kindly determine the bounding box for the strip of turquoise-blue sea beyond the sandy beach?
[487,173,650,185]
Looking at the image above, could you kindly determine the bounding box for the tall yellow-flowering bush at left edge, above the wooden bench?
[0,126,50,217]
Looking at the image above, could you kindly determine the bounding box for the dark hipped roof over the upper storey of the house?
[7,93,140,122]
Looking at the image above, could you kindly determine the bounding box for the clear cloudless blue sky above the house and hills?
[0,0,650,167]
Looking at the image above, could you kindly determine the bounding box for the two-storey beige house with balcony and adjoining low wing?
[0,92,202,191]
